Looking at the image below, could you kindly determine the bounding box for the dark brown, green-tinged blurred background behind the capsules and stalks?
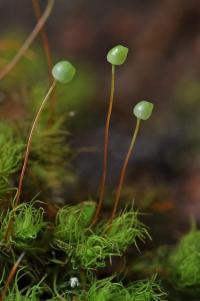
[0,0,200,243]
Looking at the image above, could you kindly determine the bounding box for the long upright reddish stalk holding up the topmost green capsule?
[92,65,115,225]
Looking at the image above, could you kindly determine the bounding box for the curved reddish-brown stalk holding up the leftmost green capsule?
[4,81,56,241]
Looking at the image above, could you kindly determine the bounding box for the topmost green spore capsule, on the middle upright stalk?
[107,45,128,65]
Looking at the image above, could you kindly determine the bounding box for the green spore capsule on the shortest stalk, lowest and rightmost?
[133,100,154,120]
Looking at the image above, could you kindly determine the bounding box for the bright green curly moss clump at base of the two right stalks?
[76,211,148,269]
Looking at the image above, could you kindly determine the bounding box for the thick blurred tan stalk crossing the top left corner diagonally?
[0,0,55,80]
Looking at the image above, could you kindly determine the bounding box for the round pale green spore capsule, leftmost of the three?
[52,61,76,84]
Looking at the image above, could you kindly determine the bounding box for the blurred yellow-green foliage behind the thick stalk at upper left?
[0,30,47,89]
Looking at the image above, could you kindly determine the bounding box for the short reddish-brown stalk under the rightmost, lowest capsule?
[109,118,140,224]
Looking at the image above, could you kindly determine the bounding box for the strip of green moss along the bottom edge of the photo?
[0,272,166,301]
